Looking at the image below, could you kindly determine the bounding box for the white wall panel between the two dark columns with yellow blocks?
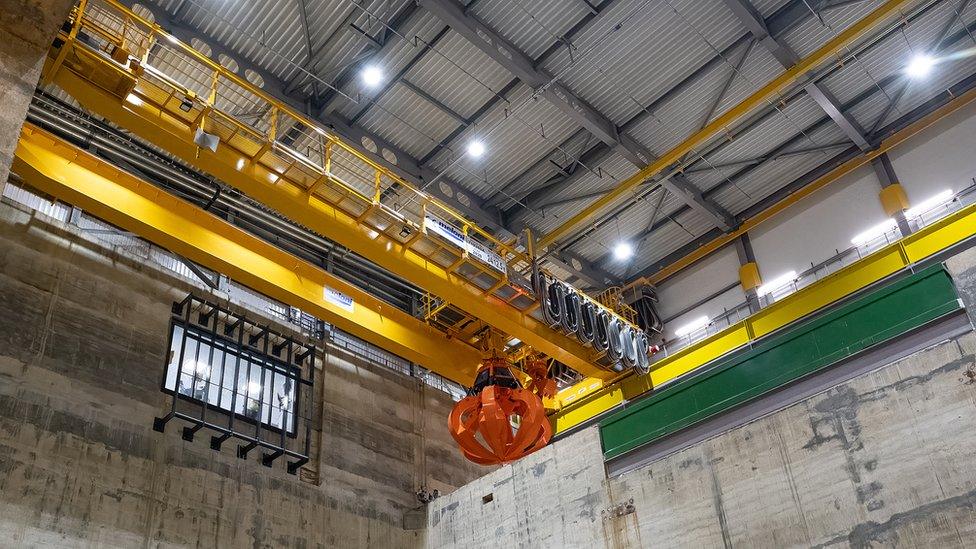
[750,166,886,280]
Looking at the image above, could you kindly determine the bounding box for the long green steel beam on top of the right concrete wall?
[600,265,960,459]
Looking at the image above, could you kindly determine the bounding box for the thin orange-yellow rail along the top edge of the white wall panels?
[627,81,976,288]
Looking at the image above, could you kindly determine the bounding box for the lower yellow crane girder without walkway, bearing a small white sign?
[13,123,481,385]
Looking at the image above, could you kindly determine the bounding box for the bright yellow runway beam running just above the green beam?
[550,198,976,432]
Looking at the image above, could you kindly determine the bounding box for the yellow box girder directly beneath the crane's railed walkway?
[45,34,614,378]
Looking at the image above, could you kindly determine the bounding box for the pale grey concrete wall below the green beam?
[427,250,976,548]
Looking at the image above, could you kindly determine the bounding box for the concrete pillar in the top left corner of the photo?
[0,0,74,190]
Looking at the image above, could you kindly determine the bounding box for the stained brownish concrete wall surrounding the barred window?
[0,199,483,548]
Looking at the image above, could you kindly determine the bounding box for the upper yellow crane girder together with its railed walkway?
[42,0,656,386]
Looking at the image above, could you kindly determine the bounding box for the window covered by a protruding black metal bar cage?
[153,295,318,473]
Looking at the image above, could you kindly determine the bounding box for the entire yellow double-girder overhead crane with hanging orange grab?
[32,0,672,463]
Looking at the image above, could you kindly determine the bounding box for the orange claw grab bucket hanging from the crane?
[448,357,555,465]
